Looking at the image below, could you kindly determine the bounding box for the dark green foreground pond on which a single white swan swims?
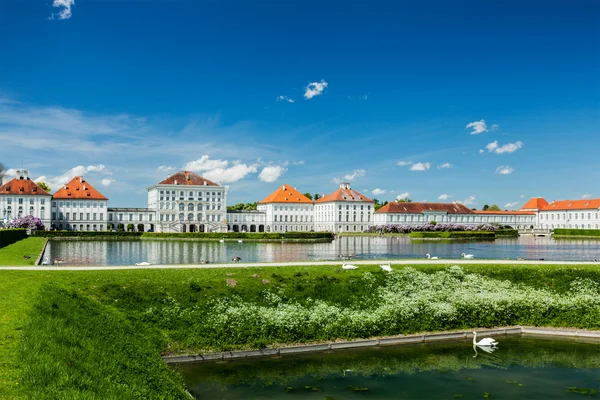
[175,337,600,400]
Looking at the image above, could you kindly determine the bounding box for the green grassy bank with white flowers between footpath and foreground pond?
[0,265,600,398]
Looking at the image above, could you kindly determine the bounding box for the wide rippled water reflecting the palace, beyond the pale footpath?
[44,236,600,265]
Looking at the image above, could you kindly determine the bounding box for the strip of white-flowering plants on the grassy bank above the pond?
[135,266,600,350]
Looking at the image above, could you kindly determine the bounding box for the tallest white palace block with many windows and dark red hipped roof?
[148,171,228,232]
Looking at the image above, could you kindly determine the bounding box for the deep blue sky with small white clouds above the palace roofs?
[0,0,600,209]
